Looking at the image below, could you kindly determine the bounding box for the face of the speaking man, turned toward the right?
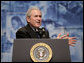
[27,10,42,28]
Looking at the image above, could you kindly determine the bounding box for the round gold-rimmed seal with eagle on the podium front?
[30,43,52,62]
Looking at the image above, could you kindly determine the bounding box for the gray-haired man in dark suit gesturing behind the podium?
[16,7,76,46]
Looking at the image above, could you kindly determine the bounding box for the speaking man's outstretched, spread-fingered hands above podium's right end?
[57,33,77,46]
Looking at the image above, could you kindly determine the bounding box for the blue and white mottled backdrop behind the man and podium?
[1,1,83,62]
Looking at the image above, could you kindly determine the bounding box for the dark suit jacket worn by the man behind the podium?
[16,24,49,39]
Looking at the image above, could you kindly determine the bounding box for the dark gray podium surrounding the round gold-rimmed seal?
[12,39,71,62]
